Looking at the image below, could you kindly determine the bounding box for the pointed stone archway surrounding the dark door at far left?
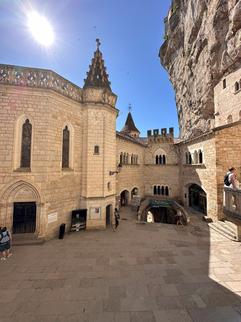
[0,180,44,236]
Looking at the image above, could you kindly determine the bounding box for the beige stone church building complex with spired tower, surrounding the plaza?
[0,43,241,239]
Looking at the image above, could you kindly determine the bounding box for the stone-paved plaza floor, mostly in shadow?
[0,208,241,322]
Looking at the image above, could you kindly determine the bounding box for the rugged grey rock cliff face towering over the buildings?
[160,0,241,139]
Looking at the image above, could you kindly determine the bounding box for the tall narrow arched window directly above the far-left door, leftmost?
[20,119,32,168]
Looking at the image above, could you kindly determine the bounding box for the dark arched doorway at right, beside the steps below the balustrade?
[188,184,207,215]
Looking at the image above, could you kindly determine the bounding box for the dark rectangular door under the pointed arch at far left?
[13,202,36,234]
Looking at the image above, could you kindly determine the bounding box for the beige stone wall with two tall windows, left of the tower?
[0,85,83,236]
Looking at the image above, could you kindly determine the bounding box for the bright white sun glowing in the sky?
[28,11,54,47]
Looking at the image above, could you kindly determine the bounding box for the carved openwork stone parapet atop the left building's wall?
[0,64,82,102]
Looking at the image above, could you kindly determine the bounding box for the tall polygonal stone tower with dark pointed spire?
[81,39,118,228]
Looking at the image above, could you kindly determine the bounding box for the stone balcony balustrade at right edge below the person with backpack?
[223,187,241,220]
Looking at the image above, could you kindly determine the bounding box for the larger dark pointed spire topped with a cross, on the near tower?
[84,38,111,91]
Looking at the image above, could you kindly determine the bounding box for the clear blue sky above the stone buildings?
[0,0,178,136]
